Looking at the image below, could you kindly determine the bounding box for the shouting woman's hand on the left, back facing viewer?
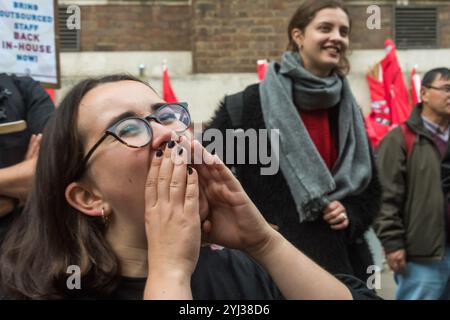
[144,142,201,299]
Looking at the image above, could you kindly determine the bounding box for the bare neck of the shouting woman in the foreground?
[106,216,148,278]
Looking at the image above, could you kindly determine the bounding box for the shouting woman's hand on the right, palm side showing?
[189,141,277,255]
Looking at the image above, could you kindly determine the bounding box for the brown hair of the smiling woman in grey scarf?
[288,0,352,75]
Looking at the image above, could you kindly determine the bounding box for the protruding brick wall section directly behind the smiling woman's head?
[192,0,398,72]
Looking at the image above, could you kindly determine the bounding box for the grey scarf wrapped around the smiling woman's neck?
[259,52,372,222]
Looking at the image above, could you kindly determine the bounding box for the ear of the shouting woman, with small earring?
[65,182,107,217]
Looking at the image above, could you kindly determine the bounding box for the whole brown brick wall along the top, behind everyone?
[75,0,450,73]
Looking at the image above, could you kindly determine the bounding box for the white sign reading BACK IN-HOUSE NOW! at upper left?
[0,0,58,85]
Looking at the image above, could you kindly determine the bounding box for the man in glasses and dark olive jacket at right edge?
[375,68,450,300]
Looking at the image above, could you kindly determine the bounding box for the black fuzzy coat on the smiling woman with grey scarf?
[204,85,381,280]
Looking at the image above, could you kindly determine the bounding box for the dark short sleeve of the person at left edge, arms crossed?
[15,77,55,134]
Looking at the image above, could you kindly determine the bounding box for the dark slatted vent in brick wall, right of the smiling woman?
[395,7,438,49]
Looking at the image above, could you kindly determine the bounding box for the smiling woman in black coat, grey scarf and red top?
[206,0,381,280]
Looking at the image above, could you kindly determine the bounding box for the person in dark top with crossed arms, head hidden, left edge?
[0,73,55,243]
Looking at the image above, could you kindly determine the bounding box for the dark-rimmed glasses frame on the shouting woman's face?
[76,102,191,177]
